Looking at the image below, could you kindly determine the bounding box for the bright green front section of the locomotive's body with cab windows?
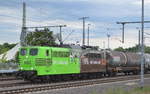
[19,46,80,79]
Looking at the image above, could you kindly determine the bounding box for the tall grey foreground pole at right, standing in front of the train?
[141,0,144,88]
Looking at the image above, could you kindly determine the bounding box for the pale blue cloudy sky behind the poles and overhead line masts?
[0,0,150,49]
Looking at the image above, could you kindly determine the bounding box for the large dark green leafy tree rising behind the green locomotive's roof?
[25,28,56,46]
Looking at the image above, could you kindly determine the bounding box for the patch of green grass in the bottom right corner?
[105,87,150,94]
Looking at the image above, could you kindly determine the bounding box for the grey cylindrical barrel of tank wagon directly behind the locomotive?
[107,51,140,67]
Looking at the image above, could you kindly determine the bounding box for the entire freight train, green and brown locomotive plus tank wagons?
[18,45,150,81]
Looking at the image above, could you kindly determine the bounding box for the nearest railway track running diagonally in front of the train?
[0,74,150,94]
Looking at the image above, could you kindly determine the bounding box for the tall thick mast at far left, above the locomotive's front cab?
[20,2,26,46]
